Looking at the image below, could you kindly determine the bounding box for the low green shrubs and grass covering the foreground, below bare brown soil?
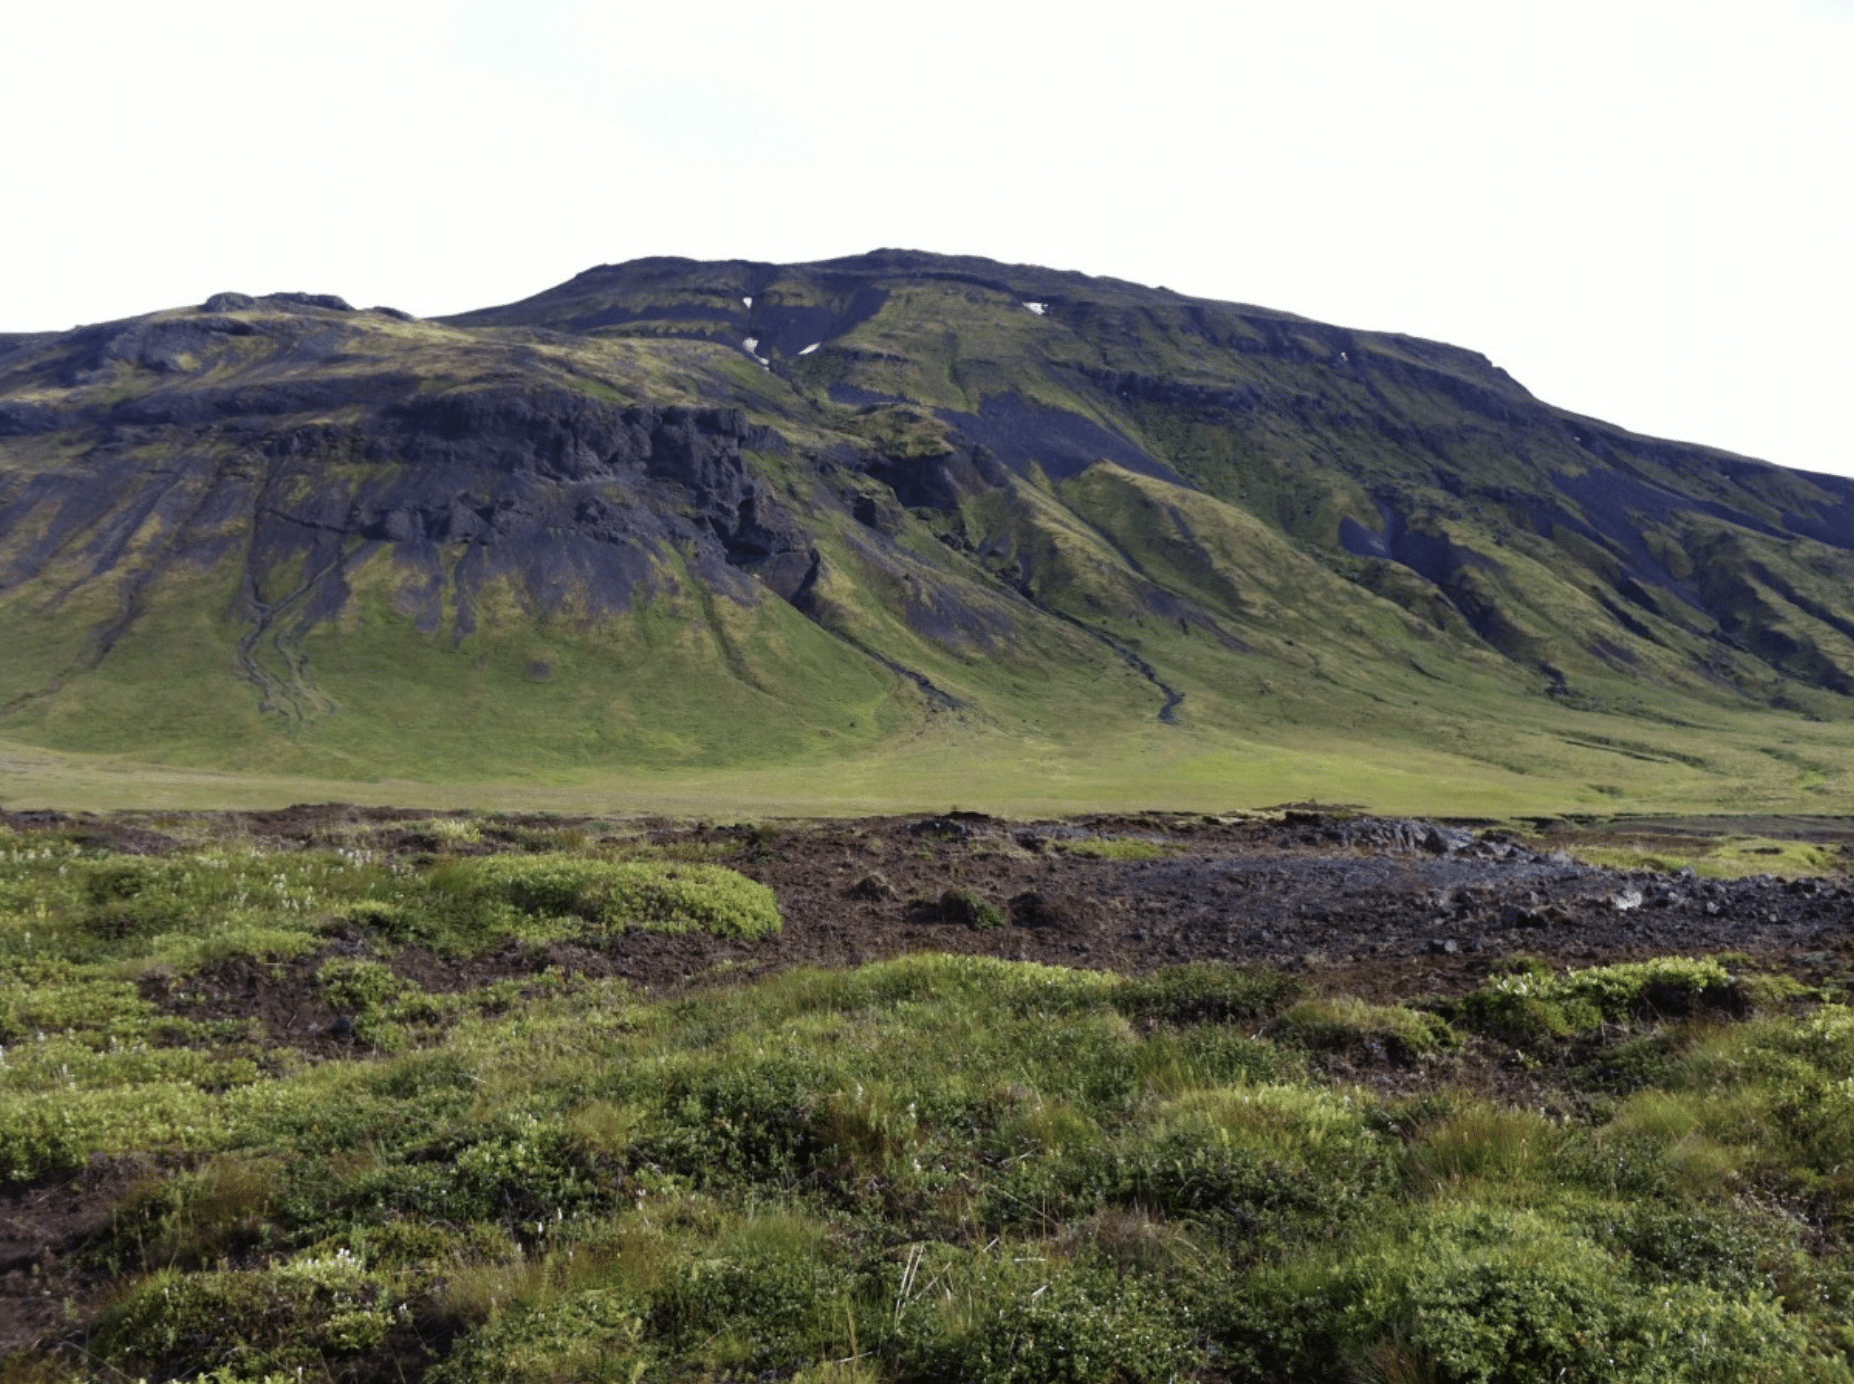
[0,822,1854,1384]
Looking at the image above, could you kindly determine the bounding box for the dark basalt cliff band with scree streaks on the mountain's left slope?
[0,361,806,633]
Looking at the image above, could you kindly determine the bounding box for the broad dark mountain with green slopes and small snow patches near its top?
[0,250,1854,805]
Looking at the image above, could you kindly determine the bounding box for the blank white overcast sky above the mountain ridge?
[0,0,1854,475]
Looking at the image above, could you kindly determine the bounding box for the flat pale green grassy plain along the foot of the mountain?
[0,671,1854,818]
